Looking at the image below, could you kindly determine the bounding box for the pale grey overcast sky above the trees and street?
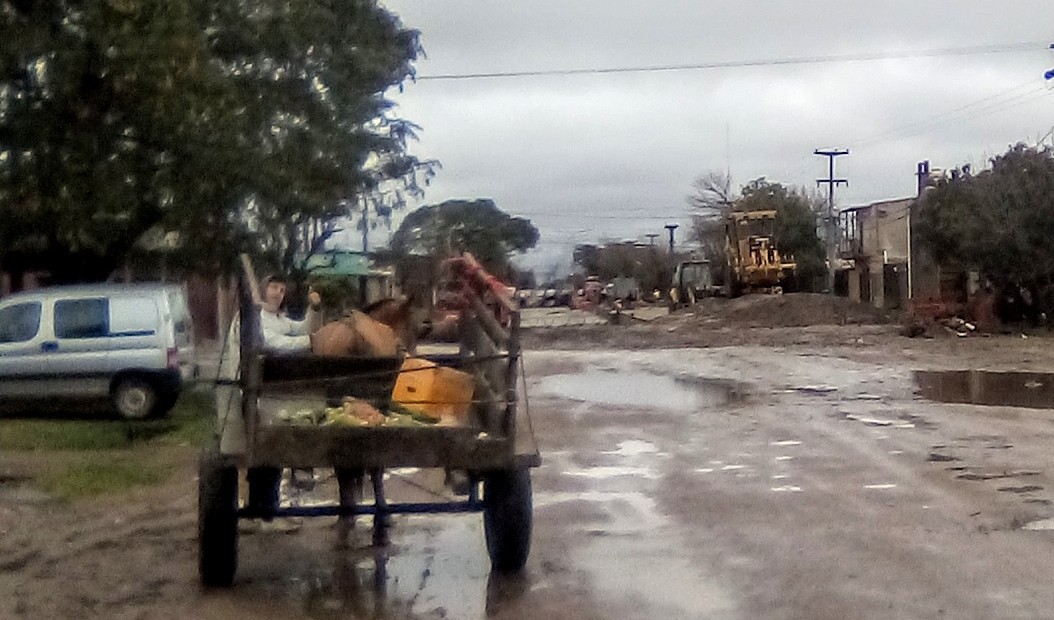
[364,0,1054,268]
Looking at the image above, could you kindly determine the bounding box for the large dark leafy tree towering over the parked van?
[0,0,428,280]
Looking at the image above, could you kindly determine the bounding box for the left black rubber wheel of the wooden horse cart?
[198,446,238,587]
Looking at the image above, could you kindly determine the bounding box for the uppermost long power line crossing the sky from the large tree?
[415,41,1050,81]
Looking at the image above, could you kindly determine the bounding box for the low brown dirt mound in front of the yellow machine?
[696,293,890,327]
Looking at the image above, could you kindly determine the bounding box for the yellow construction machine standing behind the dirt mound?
[724,211,797,297]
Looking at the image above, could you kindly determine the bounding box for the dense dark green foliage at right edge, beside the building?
[914,144,1054,287]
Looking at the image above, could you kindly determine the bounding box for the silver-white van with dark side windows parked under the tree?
[0,284,195,419]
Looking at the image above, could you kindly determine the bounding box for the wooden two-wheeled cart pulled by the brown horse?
[198,255,541,586]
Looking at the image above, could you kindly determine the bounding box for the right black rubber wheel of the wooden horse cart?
[483,467,533,571]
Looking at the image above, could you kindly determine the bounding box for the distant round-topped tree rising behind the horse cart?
[391,198,539,282]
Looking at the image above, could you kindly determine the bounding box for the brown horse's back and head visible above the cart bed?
[311,297,422,357]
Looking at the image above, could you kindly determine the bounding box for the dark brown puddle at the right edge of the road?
[915,370,1054,409]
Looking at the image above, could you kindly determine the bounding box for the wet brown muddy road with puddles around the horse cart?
[0,332,1054,620]
